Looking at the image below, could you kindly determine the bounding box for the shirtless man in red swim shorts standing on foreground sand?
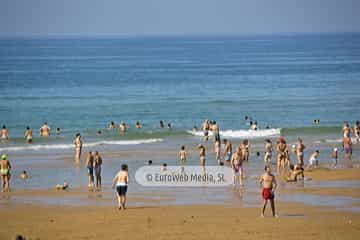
[259,166,276,217]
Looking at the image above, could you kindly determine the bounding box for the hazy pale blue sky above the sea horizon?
[0,0,360,36]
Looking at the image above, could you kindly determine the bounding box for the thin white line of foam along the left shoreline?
[0,138,163,151]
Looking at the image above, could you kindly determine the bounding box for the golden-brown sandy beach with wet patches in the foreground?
[0,168,360,239]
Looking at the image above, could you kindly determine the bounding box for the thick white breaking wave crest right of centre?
[187,128,281,138]
